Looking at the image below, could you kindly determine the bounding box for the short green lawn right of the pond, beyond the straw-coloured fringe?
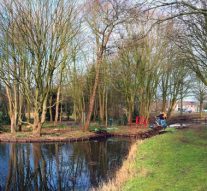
[122,127,207,191]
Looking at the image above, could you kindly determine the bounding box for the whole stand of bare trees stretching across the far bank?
[0,0,207,136]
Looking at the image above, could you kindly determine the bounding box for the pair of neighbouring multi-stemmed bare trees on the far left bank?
[0,0,78,135]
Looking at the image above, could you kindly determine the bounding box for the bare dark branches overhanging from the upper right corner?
[150,0,207,85]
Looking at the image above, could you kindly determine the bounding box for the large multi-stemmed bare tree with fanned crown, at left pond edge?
[0,0,78,136]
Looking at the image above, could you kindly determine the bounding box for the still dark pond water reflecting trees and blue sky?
[0,138,131,191]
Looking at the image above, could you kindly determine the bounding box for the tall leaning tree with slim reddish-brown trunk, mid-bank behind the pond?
[84,0,134,130]
